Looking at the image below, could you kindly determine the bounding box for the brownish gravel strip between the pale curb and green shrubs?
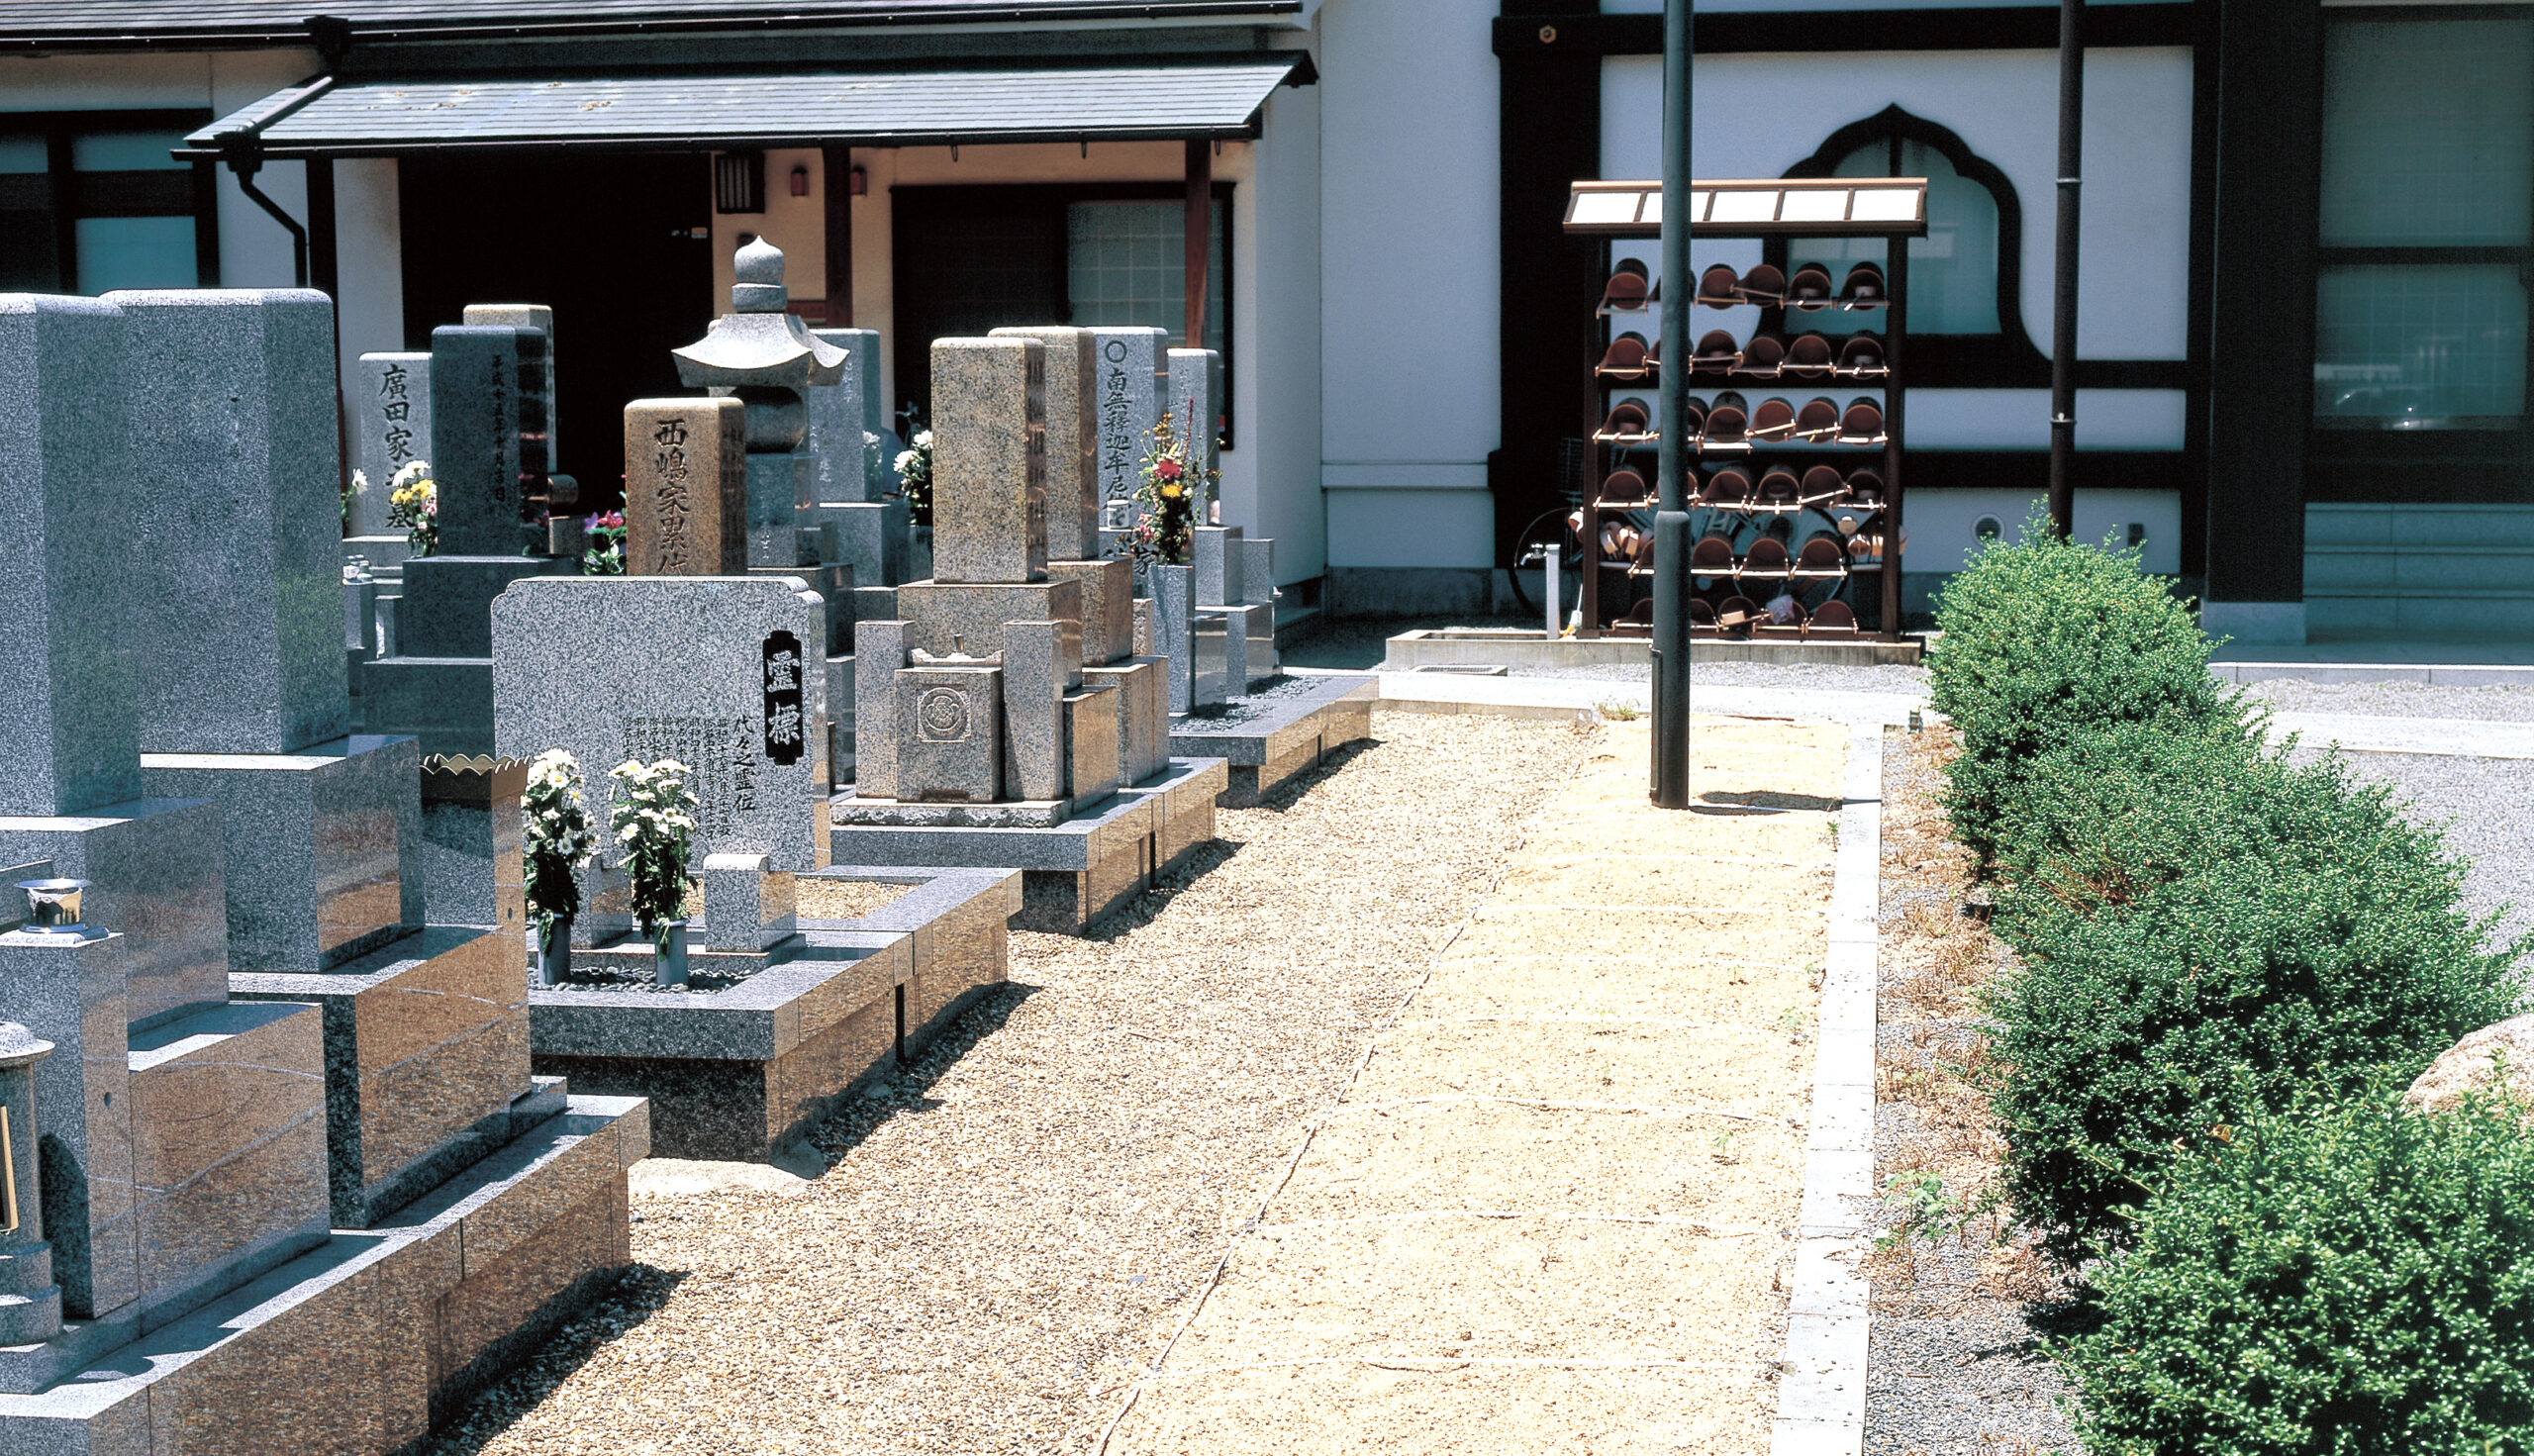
[1865,734,2076,1456]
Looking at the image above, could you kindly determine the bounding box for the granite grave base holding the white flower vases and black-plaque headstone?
[530,866,1022,1162]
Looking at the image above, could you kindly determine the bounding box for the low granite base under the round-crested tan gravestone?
[828,757,1229,934]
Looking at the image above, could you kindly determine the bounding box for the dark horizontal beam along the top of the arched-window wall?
[1495,3,2197,58]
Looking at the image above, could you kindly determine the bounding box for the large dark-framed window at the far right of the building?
[2313,13,2534,431]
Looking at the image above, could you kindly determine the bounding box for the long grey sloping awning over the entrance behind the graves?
[175,53,1313,157]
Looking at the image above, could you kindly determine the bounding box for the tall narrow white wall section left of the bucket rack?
[1320,0,1501,567]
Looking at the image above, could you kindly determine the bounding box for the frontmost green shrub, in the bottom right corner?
[2063,1086,2534,1456]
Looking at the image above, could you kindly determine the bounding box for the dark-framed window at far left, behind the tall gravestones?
[0,112,221,294]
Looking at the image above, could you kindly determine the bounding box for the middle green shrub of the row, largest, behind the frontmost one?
[1982,725,2526,1264]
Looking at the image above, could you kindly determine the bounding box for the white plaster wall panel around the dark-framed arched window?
[1602,47,2192,364]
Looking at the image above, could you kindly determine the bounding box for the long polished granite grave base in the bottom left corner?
[0,1089,648,1456]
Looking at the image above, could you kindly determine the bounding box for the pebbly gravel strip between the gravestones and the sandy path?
[434,714,1599,1456]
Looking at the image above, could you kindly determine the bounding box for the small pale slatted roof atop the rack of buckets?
[1566,177,1926,238]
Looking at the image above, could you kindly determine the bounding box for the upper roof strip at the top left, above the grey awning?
[0,0,1303,49]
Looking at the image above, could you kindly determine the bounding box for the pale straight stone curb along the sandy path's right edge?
[1769,725,1883,1456]
